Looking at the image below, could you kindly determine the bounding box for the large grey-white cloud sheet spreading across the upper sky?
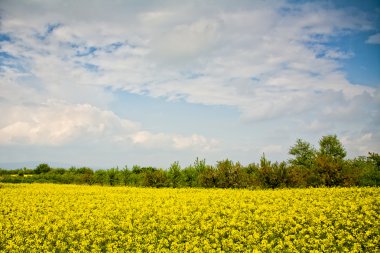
[1,0,372,119]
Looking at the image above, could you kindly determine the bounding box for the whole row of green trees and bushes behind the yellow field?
[0,135,380,189]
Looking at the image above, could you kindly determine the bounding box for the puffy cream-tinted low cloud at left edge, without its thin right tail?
[0,101,138,146]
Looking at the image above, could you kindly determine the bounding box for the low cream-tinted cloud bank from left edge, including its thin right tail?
[0,101,218,150]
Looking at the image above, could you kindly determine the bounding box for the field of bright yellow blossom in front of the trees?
[0,184,380,252]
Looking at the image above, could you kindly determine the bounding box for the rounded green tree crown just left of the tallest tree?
[289,139,316,168]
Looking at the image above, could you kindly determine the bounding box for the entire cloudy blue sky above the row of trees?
[0,0,380,168]
